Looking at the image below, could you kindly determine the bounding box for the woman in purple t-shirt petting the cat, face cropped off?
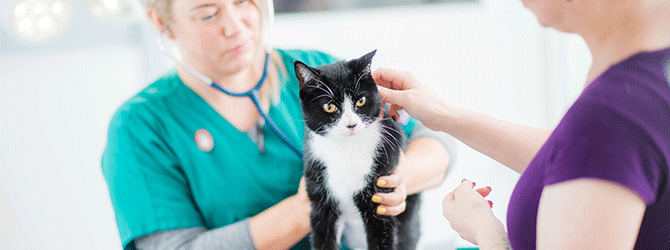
[373,0,670,249]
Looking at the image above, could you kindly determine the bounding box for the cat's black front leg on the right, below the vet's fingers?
[354,188,398,250]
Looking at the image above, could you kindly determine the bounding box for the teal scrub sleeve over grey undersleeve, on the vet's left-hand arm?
[102,105,205,249]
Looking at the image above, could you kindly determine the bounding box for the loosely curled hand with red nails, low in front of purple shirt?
[442,180,504,244]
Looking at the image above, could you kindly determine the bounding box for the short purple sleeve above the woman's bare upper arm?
[544,101,662,205]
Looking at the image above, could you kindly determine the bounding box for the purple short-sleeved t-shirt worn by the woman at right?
[507,48,670,250]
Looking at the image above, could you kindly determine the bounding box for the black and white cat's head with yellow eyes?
[294,50,381,136]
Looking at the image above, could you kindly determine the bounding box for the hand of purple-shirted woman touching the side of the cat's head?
[372,68,451,131]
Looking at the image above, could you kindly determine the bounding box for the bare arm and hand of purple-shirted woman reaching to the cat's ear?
[373,68,551,173]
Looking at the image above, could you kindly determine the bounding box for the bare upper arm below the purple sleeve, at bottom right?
[537,179,646,250]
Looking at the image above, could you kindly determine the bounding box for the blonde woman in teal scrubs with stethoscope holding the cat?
[102,0,450,249]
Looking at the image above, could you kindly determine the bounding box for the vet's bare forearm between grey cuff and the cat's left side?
[249,196,310,249]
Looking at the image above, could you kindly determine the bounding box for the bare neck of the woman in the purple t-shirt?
[577,0,670,84]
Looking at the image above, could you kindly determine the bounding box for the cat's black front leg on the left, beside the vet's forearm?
[310,199,340,250]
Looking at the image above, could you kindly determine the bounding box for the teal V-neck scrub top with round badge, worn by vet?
[102,50,417,249]
